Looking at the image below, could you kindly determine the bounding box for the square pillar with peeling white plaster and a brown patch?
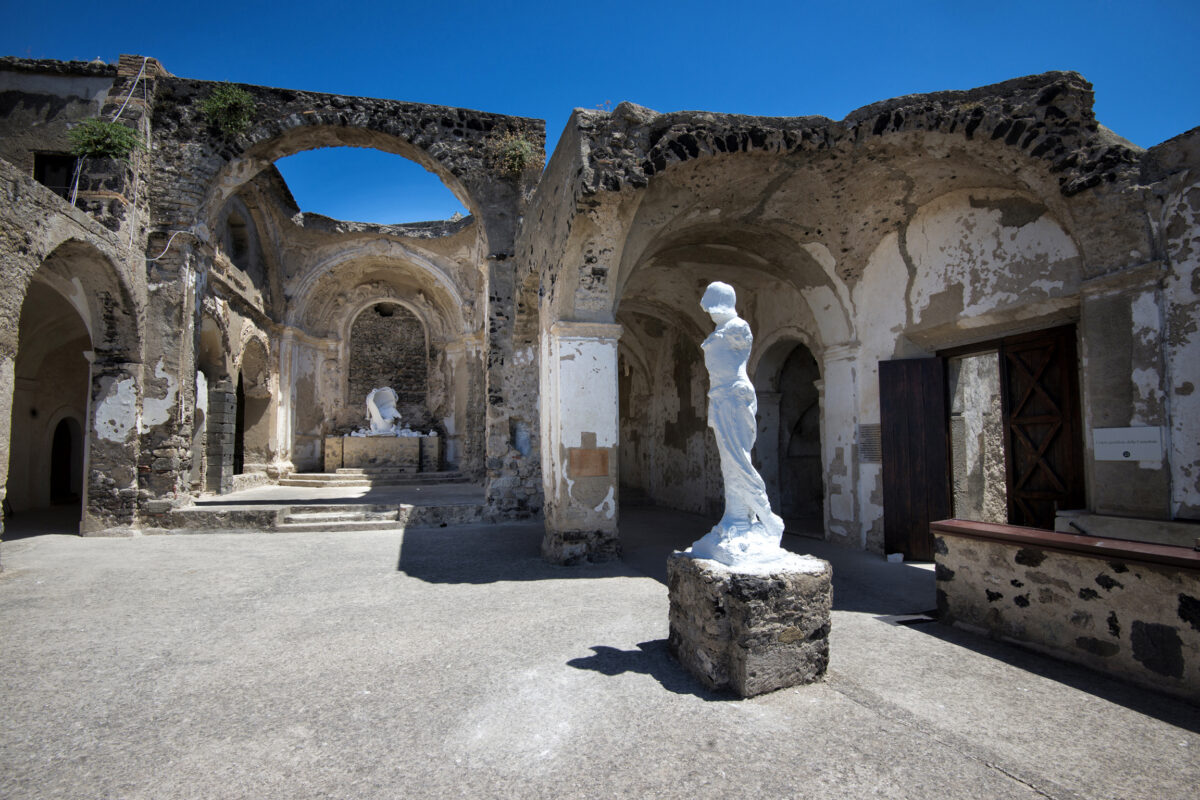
[541,321,622,564]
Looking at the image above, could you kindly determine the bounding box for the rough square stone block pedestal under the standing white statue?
[667,553,833,697]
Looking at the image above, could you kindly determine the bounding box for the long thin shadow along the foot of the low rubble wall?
[911,622,1200,735]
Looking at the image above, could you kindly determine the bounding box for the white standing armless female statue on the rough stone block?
[690,281,794,567]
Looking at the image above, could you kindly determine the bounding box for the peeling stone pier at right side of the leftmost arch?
[79,351,142,534]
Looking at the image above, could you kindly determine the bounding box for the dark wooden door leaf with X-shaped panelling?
[1000,325,1084,530]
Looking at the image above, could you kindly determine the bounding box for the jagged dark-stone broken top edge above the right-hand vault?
[559,72,1146,197]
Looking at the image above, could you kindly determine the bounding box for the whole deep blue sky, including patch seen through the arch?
[0,0,1200,222]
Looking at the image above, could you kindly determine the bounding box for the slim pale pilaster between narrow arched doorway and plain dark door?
[814,342,866,548]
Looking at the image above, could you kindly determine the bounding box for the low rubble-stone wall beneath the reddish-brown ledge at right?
[936,529,1200,699]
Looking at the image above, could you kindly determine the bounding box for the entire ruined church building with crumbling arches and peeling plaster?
[0,56,1200,690]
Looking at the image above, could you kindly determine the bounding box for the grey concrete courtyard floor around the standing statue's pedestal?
[0,509,1200,800]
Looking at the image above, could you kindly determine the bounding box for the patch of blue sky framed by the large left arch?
[275,148,470,224]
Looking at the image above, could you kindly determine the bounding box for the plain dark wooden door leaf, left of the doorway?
[880,359,950,561]
